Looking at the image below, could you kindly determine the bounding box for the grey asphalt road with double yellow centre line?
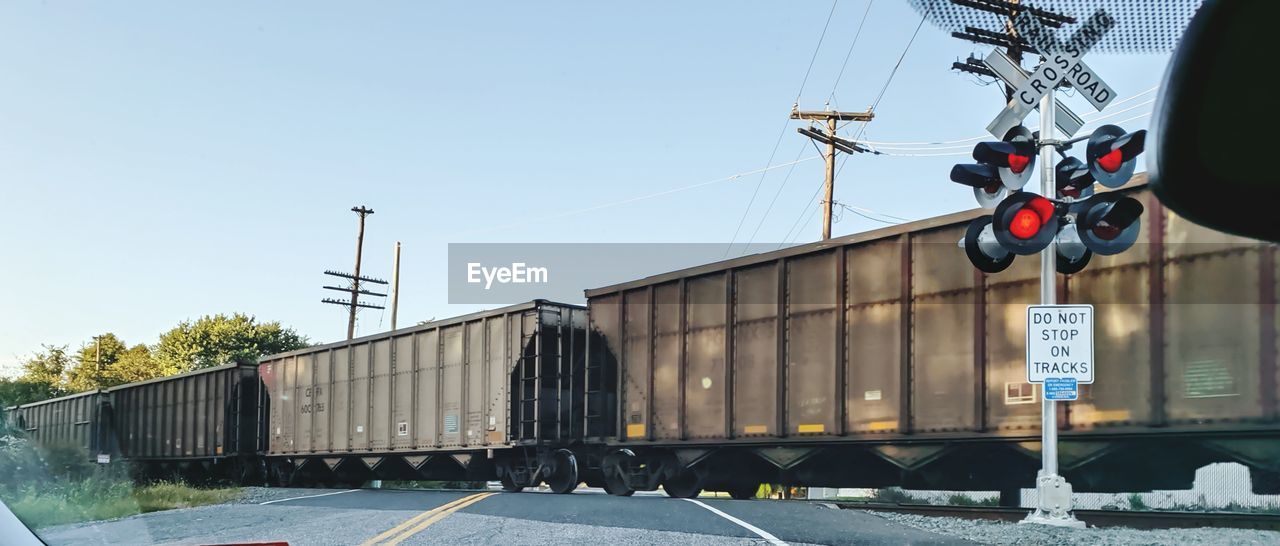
[32,490,957,546]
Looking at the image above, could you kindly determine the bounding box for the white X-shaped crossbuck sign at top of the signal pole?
[987,10,1116,138]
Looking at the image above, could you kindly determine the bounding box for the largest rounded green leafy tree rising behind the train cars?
[154,313,307,372]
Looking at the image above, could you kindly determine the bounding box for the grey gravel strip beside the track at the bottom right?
[868,511,1280,546]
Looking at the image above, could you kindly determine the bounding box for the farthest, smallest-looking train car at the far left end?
[8,390,113,462]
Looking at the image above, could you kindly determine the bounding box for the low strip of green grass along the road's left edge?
[4,478,239,528]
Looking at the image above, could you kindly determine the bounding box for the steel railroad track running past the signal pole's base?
[835,503,1280,531]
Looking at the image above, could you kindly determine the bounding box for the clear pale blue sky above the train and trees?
[0,0,1167,371]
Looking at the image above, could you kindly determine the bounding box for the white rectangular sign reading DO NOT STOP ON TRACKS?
[1027,306,1093,384]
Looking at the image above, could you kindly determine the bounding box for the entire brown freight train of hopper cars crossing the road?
[2,183,1280,500]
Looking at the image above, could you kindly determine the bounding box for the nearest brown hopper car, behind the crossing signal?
[586,175,1280,496]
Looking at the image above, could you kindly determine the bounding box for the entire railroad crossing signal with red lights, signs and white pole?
[951,0,1146,528]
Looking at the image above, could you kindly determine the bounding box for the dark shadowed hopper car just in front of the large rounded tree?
[106,363,265,483]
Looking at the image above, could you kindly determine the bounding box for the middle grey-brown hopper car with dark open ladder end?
[260,300,588,492]
